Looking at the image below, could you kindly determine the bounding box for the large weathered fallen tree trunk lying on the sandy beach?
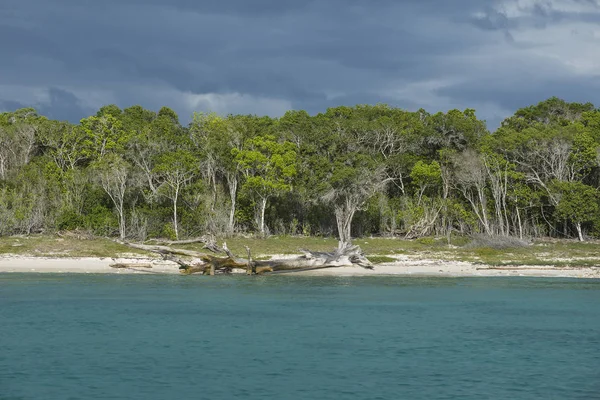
[122,242,373,275]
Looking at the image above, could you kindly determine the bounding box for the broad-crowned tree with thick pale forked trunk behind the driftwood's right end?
[301,106,393,246]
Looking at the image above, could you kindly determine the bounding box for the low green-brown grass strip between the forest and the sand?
[0,235,600,267]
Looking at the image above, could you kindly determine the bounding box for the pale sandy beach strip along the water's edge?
[0,255,600,279]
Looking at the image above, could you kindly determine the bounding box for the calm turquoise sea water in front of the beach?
[0,274,600,400]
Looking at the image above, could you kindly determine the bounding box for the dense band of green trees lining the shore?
[0,98,600,242]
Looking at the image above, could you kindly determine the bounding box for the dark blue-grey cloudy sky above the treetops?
[0,0,600,130]
